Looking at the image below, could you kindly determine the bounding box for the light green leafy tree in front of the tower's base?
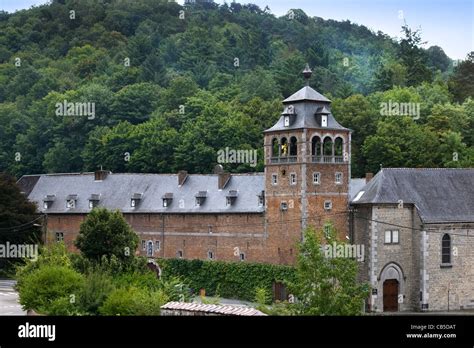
[289,225,369,315]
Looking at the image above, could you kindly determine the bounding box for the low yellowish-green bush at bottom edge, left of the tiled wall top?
[99,287,167,315]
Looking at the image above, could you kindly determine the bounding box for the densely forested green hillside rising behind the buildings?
[0,0,474,176]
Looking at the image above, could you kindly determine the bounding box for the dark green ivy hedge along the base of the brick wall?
[158,259,295,301]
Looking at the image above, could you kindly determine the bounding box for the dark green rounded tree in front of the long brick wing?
[74,208,138,262]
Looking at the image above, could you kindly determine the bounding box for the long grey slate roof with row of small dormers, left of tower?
[18,173,265,214]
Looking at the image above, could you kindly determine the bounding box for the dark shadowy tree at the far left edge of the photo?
[0,173,42,272]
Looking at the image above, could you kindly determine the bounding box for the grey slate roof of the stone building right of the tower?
[351,168,474,223]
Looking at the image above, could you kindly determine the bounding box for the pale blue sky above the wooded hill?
[0,0,474,59]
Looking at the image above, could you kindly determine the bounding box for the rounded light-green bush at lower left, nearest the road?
[19,265,84,313]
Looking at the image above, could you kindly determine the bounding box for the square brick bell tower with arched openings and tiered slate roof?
[264,65,351,263]
